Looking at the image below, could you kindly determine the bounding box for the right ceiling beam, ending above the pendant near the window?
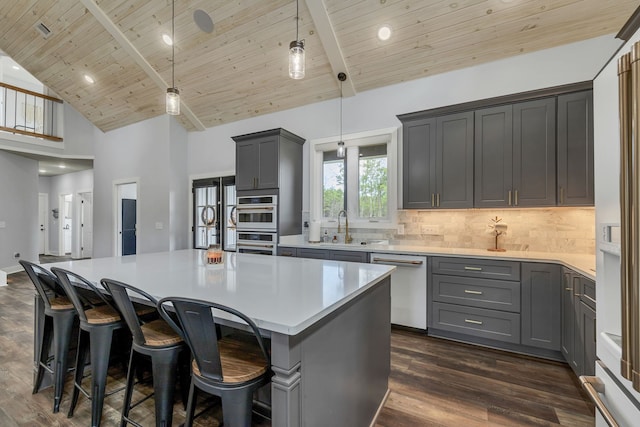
[305,0,356,97]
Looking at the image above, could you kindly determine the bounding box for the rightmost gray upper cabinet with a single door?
[557,90,594,206]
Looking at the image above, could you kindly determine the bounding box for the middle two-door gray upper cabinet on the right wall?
[475,98,556,207]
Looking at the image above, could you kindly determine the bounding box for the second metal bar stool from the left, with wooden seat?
[51,267,150,427]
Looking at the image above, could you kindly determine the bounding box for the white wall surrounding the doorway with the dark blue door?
[94,114,188,257]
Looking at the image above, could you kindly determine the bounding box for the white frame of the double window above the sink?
[309,127,399,229]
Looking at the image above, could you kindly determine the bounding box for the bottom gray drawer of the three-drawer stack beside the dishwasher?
[430,302,520,344]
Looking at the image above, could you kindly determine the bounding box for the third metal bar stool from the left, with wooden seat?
[100,279,189,427]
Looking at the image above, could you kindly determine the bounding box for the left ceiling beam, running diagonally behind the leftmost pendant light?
[80,0,206,131]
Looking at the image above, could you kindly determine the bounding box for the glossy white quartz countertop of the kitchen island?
[46,249,395,335]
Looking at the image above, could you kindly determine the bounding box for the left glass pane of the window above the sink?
[322,151,345,218]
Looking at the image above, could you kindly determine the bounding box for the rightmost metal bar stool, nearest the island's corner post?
[158,297,272,427]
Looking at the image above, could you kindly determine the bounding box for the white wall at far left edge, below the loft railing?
[0,151,39,272]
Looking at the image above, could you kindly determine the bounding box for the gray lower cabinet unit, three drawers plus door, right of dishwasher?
[427,257,562,360]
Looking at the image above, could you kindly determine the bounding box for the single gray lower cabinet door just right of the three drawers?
[521,262,562,351]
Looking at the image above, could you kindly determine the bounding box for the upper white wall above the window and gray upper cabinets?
[189,35,621,211]
